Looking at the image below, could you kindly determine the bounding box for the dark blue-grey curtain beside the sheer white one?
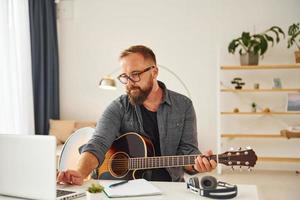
[29,0,59,135]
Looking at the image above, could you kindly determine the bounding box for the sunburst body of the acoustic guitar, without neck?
[98,132,155,180]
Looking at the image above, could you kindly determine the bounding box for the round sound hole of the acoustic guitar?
[110,152,129,178]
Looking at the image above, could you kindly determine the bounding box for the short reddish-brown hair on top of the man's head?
[120,45,156,65]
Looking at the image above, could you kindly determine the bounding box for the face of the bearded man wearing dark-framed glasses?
[120,53,156,105]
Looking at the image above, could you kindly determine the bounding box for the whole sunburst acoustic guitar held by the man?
[98,132,257,180]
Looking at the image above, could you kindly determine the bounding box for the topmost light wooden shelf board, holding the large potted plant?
[221,63,300,70]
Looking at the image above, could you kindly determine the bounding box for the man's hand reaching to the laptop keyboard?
[56,170,83,185]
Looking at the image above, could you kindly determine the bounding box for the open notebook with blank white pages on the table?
[100,179,162,197]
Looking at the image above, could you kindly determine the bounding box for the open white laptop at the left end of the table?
[0,134,85,200]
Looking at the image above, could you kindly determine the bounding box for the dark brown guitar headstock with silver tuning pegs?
[219,148,257,168]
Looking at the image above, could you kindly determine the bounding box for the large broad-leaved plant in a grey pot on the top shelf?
[228,26,285,65]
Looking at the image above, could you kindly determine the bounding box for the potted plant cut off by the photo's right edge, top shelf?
[288,23,300,63]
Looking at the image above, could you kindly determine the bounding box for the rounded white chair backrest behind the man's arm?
[58,127,95,171]
